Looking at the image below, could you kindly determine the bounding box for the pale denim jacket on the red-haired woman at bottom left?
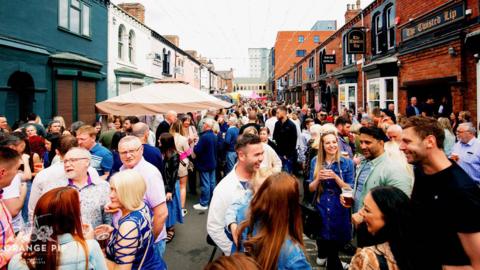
[8,233,107,270]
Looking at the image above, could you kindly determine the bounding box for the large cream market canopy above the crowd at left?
[95,82,233,116]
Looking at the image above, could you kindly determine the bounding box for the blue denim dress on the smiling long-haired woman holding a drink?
[308,157,355,244]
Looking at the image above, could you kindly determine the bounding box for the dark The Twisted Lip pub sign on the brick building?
[402,3,465,41]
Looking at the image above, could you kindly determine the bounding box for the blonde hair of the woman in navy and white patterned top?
[110,170,147,211]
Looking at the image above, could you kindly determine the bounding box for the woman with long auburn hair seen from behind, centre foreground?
[238,173,311,269]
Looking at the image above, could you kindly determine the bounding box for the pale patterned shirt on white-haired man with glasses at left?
[43,175,112,228]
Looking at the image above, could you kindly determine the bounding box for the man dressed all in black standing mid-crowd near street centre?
[273,106,298,173]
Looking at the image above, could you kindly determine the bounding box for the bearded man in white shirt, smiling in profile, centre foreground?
[207,134,263,255]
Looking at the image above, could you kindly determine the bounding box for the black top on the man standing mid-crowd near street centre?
[273,119,297,158]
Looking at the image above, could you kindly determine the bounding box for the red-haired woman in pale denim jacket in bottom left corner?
[8,187,107,270]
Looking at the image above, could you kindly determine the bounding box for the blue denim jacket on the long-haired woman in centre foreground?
[225,190,311,270]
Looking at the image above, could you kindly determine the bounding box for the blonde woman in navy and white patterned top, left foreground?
[95,170,166,269]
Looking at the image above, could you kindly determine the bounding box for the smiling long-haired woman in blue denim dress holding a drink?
[308,131,354,270]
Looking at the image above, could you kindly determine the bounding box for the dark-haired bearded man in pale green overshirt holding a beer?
[341,127,413,247]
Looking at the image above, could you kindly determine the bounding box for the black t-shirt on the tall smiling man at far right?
[411,162,480,269]
